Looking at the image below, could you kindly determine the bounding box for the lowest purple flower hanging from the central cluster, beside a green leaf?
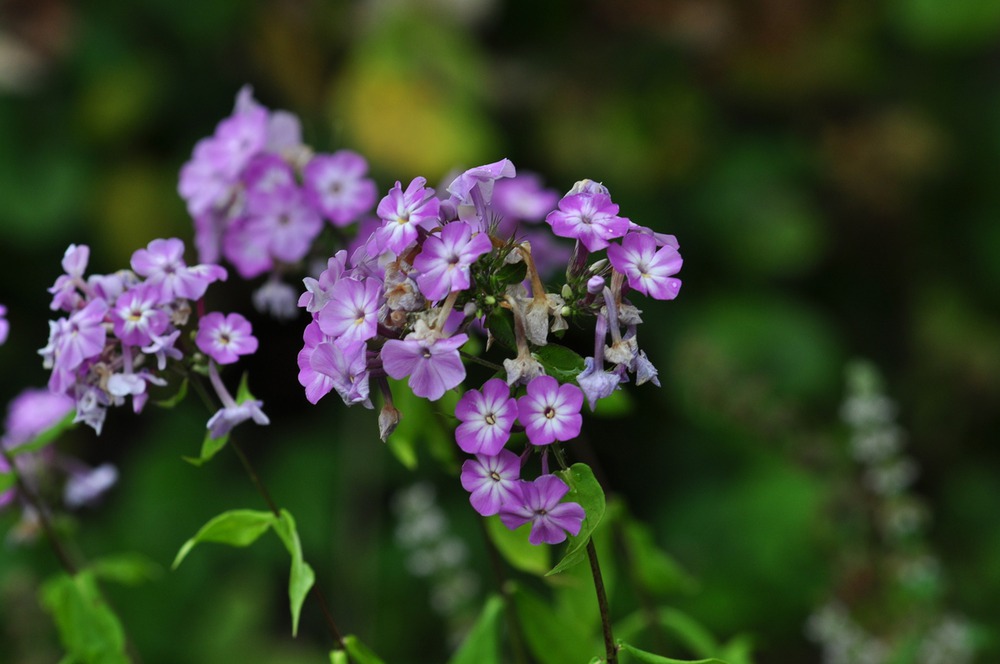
[500,475,586,544]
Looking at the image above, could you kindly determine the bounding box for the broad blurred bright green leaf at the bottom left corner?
[41,571,129,664]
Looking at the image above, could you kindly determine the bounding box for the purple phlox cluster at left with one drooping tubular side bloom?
[39,238,267,436]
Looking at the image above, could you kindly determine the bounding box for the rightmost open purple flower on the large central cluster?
[608,233,683,300]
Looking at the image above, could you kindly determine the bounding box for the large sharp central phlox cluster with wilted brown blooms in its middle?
[298,159,681,544]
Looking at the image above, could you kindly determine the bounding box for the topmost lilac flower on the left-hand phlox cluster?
[131,238,226,304]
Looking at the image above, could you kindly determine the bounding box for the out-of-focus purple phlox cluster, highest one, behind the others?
[178,87,376,317]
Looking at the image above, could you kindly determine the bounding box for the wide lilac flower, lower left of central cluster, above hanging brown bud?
[382,334,469,401]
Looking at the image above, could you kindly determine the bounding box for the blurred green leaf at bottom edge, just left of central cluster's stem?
[513,586,599,664]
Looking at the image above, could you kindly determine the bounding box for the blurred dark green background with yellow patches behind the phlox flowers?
[0,0,1000,664]
